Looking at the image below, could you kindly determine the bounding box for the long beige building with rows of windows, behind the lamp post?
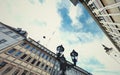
[0,23,91,75]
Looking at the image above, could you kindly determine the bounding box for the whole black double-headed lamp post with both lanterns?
[56,45,78,75]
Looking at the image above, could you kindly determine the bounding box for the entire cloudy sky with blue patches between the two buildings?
[0,0,120,75]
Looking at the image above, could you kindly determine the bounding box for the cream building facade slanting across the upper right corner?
[70,0,120,62]
